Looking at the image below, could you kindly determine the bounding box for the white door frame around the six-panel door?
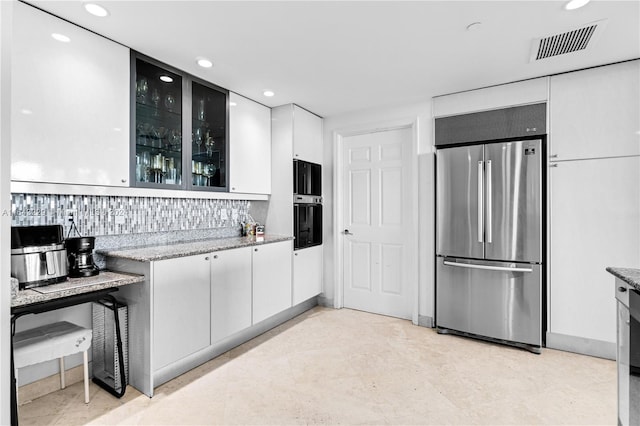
[333,117,420,325]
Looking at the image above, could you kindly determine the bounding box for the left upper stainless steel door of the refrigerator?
[436,145,484,258]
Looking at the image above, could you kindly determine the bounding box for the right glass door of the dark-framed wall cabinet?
[191,81,228,190]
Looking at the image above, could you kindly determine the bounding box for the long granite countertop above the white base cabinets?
[96,235,293,262]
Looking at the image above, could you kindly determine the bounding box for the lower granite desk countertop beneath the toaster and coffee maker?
[11,271,144,308]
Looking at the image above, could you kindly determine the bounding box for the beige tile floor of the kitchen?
[20,307,617,426]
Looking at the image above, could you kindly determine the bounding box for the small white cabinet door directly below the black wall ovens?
[293,246,322,305]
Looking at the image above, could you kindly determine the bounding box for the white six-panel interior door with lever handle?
[342,128,416,319]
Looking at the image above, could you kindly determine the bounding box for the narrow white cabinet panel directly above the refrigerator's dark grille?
[433,77,549,117]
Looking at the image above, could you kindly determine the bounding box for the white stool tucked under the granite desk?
[13,321,92,404]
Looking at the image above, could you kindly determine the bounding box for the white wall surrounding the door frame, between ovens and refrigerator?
[323,100,435,325]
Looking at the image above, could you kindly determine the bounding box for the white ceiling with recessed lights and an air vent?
[21,0,640,117]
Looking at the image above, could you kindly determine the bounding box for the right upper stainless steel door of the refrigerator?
[484,140,543,262]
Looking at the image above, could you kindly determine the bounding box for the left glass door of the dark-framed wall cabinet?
[135,58,183,186]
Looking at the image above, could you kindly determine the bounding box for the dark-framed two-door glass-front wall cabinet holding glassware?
[131,53,228,191]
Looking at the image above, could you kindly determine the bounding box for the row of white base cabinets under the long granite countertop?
[107,240,300,396]
